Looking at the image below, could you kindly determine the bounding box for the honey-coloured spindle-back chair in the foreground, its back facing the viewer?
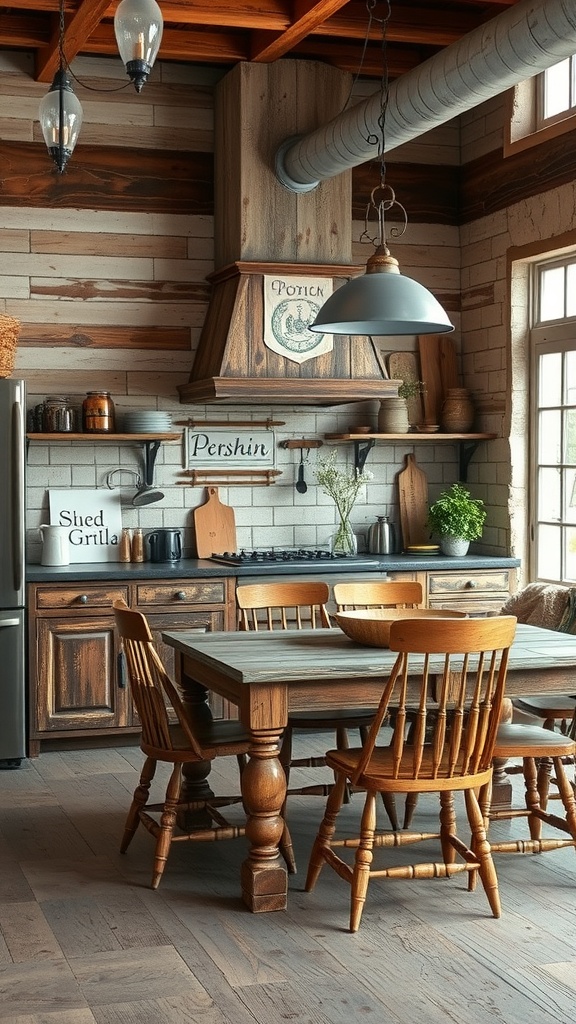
[305,615,517,932]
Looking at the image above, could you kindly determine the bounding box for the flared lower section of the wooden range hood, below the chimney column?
[178,262,398,406]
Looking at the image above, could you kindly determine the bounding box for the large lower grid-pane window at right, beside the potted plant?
[531,256,576,584]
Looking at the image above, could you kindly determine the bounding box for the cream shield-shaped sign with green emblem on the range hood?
[263,274,334,362]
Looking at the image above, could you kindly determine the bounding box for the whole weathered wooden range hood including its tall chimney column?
[178,59,398,406]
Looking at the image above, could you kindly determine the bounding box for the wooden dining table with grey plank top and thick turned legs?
[162,624,576,912]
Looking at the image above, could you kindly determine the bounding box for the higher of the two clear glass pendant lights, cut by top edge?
[114,0,164,92]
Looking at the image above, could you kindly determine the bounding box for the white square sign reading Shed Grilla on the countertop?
[48,487,122,562]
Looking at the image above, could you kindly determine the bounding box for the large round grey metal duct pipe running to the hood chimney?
[276,0,576,193]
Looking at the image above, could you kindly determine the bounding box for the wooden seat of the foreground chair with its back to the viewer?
[326,746,492,793]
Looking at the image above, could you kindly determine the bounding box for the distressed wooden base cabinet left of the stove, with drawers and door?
[29,579,235,757]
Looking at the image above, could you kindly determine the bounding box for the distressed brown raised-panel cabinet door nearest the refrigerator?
[36,615,129,731]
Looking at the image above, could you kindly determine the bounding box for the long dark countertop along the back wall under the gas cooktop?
[26,555,520,583]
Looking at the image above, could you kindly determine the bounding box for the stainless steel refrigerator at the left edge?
[0,379,26,769]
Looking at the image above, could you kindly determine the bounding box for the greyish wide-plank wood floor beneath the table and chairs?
[0,736,576,1024]
